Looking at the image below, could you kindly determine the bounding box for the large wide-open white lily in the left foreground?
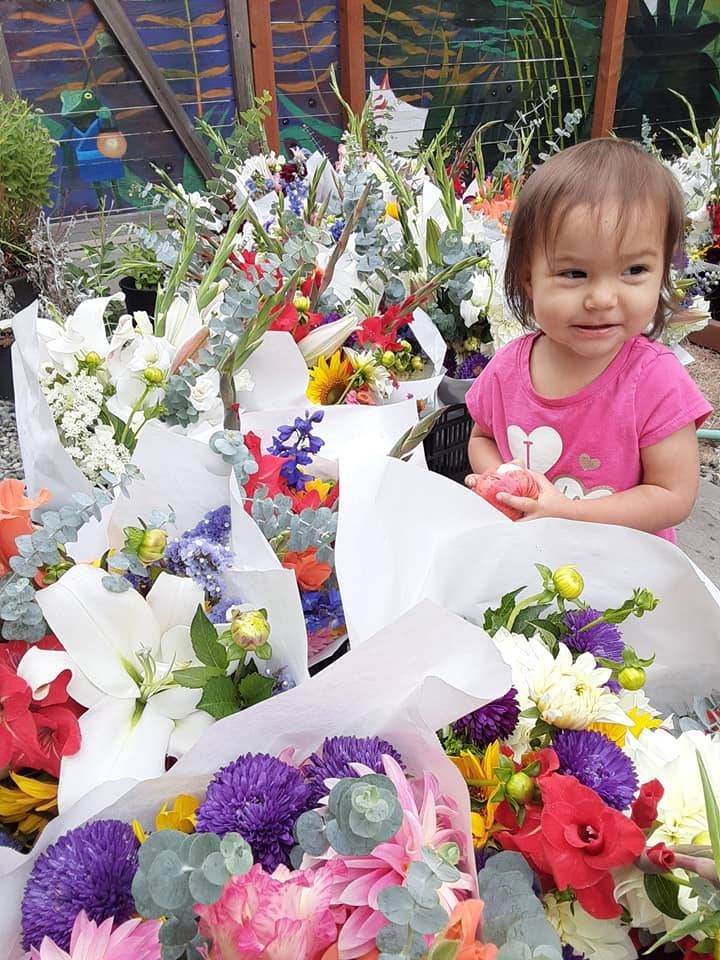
[18,564,213,811]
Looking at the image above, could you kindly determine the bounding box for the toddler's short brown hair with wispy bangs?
[505,137,685,337]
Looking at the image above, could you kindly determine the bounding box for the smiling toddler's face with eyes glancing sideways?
[526,205,665,360]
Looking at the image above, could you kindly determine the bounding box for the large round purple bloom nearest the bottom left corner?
[22,820,140,950]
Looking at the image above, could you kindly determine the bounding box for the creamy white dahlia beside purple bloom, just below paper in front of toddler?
[494,628,631,730]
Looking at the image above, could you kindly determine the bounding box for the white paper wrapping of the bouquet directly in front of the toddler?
[336,459,720,712]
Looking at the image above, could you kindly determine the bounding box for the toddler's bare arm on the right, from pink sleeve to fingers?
[496,424,700,533]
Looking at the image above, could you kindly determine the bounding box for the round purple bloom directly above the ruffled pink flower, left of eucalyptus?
[196,753,313,872]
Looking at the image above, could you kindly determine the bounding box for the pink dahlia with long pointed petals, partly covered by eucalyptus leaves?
[331,756,473,960]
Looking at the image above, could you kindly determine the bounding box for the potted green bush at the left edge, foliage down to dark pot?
[0,97,54,400]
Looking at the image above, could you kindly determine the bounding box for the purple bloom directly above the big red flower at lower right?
[553,730,638,810]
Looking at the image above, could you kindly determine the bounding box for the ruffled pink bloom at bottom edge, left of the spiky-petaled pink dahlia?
[195,861,347,960]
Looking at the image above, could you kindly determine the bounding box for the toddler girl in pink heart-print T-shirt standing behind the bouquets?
[466,138,711,542]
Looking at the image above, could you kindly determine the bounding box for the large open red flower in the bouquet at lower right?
[498,774,645,920]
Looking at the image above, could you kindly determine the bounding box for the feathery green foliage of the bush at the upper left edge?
[0,97,54,267]
